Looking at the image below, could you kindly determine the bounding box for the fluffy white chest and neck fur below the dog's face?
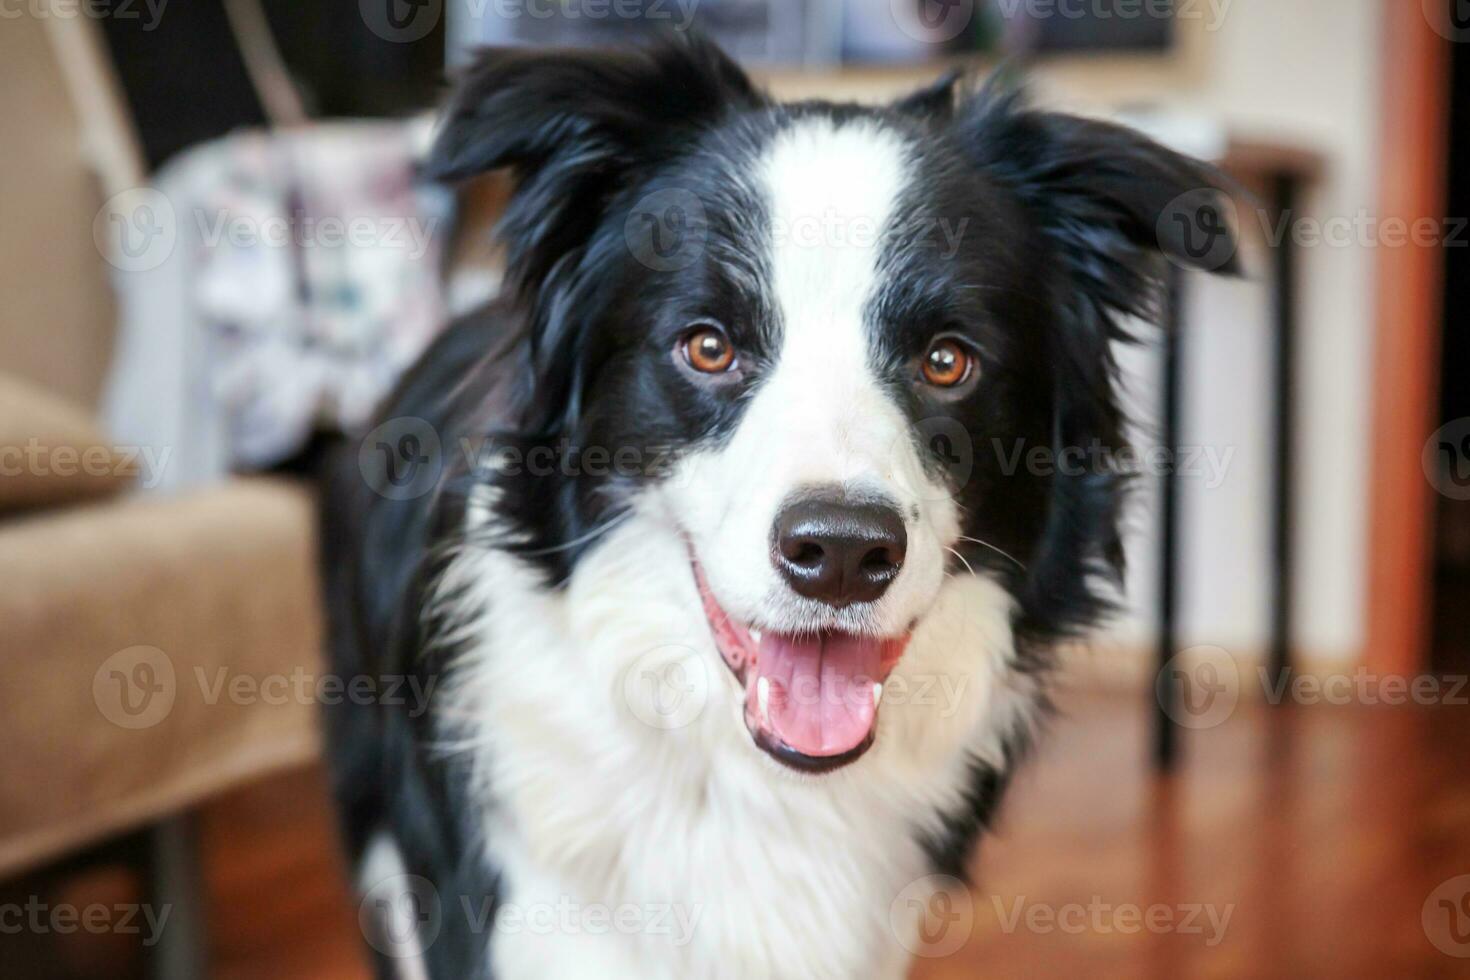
[429,514,1033,980]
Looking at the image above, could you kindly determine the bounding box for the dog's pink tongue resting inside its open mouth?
[757,633,885,755]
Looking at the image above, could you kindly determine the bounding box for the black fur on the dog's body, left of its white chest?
[320,314,517,979]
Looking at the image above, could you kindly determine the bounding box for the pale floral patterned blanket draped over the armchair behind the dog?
[98,122,453,488]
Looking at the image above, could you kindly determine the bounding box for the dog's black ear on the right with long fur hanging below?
[950,82,1239,632]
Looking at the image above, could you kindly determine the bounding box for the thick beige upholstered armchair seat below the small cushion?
[0,479,322,876]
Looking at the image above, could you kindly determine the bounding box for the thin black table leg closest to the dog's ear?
[1151,266,1185,770]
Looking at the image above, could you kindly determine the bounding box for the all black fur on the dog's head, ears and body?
[323,38,1220,977]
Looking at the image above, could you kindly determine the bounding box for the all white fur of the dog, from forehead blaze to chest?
[426,120,1036,980]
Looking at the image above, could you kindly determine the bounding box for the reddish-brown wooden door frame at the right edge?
[1363,0,1451,674]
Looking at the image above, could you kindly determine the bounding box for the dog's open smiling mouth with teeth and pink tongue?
[694,561,908,773]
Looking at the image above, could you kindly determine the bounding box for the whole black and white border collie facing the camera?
[323,38,1222,980]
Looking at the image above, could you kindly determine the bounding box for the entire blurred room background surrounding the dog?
[0,0,1470,979]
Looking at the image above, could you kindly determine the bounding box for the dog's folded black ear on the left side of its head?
[426,32,764,295]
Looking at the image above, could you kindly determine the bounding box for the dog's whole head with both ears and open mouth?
[432,40,1229,770]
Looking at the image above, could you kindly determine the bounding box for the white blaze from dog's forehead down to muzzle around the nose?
[669,118,957,636]
